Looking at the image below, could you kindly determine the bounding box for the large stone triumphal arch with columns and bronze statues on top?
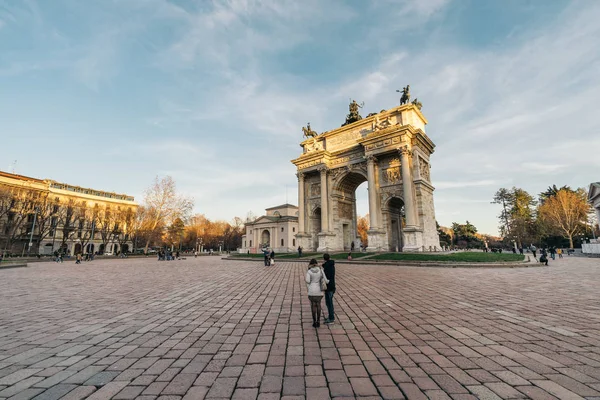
[292,94,440,251]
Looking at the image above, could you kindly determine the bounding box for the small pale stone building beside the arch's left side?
[238,204,298,254]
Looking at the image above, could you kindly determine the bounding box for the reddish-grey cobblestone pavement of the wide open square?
[0,257,600,400]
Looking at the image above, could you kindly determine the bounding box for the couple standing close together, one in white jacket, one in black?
[305,253,335,328]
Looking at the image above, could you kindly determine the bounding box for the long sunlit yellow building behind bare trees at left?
[0,171,138,255]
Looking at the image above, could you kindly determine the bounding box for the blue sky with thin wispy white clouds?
[0,0,600,234]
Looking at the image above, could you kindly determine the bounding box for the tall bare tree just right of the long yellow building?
[144,176,194,252]
